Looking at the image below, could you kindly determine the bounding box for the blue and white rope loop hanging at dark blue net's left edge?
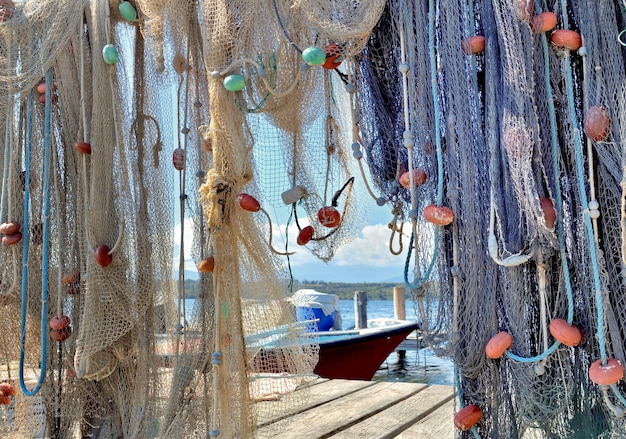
[399,0,443,290]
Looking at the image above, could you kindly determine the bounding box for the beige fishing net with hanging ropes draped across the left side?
[0,0,384,439]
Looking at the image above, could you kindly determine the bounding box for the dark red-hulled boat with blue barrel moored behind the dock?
[246,290,418,381]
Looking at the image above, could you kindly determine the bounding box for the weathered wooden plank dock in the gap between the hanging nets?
[256,379,455,439]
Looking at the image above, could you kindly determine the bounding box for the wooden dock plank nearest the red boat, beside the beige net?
[255,379,376,427]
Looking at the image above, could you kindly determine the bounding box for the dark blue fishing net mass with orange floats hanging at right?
[357,0,626,438]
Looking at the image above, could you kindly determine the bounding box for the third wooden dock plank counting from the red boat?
[332,385,454,439]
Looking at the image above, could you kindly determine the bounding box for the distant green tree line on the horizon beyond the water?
[185,279,399,300]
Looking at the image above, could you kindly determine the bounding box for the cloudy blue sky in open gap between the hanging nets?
[174,201,410,283]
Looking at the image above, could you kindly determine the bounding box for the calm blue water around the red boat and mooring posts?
[339,300,454,386]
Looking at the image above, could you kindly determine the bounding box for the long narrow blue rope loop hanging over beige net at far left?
[19,71,52,396]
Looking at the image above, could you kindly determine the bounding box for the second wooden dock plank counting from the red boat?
[256,380,428,439]
